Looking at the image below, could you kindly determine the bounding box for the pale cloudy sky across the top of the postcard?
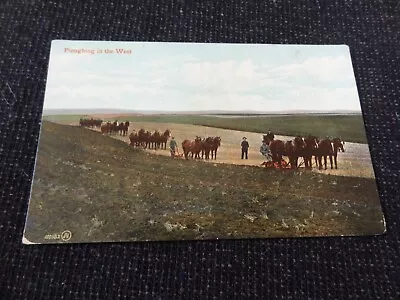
[44,41,360,111]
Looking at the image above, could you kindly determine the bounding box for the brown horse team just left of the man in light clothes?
[129,128,171,149]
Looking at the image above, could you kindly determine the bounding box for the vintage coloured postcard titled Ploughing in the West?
[23,40,385,244]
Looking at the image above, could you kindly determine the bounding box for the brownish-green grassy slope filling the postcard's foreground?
[25,121,384,242]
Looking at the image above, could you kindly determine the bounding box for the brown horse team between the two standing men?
[182,136,221,159]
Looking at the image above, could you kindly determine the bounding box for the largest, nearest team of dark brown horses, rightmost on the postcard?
[264,135,345,170]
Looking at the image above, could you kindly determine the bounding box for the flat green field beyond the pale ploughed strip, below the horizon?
[45,114,367,144]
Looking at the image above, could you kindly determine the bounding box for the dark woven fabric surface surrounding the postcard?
[0,0,400,300]
